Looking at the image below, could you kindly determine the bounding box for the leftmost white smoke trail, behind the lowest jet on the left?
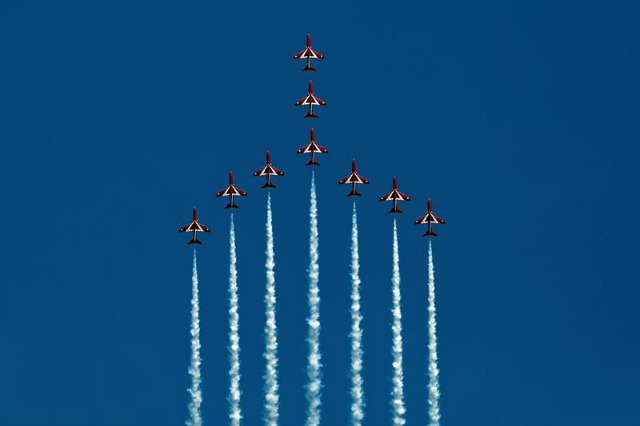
[186,249,202,426]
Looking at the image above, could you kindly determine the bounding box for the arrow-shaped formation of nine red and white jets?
[179,34,445,244]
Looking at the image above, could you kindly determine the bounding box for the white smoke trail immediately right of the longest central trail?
[350,201,364,426]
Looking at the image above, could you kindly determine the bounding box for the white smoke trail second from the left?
[229,213,242,426]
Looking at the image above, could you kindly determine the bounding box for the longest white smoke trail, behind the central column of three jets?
[306,172,322,426]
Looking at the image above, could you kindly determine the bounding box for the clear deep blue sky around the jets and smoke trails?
[0,0,640,426]
